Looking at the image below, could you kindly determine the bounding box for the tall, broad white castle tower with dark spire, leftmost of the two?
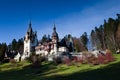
[23,22,38,58]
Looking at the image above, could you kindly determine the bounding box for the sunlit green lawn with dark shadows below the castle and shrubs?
[0,54,120,80]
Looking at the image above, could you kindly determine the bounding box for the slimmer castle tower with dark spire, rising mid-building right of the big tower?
[52,24,59,54]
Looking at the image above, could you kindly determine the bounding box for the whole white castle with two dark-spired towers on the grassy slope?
[21,22,73,60]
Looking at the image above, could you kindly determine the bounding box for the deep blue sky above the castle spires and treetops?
[0,0,120,44]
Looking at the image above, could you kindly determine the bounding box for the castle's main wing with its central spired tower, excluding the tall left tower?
[35,25,68,56]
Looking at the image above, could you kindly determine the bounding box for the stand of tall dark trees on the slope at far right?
[91,15,120,51]
